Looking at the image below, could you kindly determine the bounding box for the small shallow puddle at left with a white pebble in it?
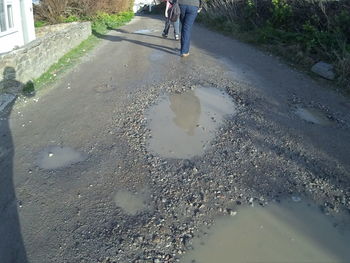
[37,146,85,169]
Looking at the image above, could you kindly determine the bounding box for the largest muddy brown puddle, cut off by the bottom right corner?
[180,201,350,263]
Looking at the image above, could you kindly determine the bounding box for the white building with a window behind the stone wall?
[0,0,35,53]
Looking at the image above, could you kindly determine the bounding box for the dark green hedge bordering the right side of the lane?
[199,0,350,92]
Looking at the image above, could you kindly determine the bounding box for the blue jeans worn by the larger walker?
[180,5,198,54]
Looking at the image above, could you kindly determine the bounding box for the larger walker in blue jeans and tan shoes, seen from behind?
[178,0,201,57]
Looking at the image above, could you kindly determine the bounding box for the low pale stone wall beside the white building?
[0,22,91,93]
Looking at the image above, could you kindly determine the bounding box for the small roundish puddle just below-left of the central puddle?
[114,190,149,215]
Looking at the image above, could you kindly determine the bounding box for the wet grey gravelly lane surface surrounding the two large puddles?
[0,14,350,263]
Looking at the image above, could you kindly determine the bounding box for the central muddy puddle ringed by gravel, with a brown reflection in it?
[146,87,236,158]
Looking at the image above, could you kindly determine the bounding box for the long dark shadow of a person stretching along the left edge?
[0,67,28,263]
